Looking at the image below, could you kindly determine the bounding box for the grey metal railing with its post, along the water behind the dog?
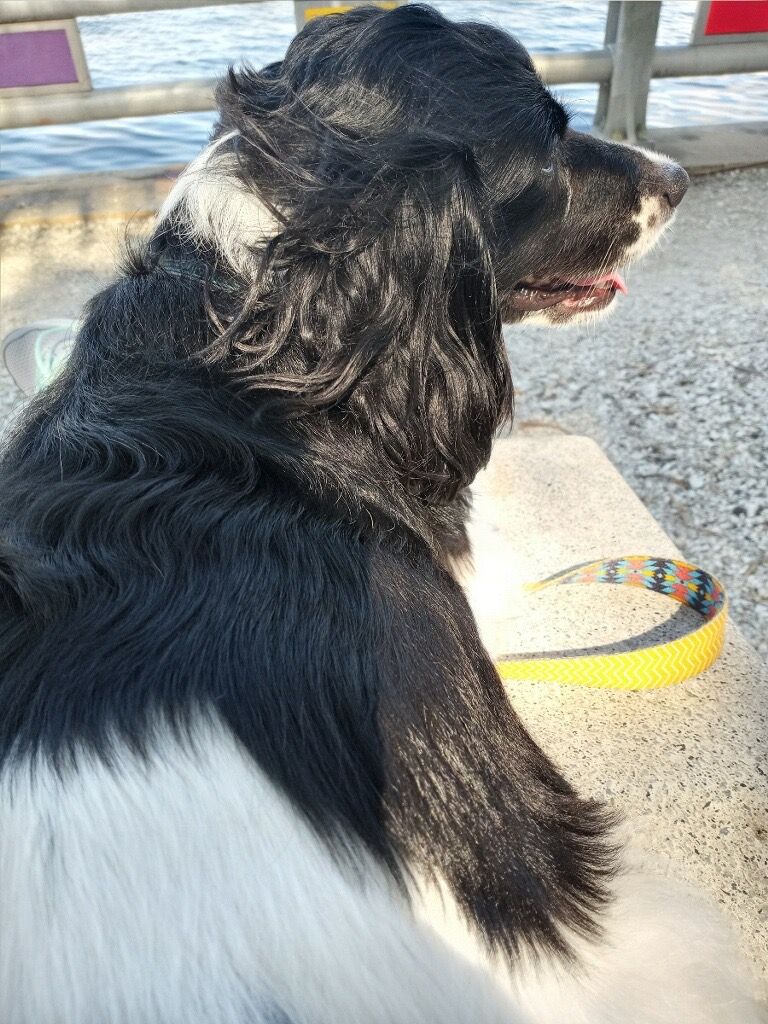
[0,0,768,140]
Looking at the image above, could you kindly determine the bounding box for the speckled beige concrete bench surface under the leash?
[468,430,768,978]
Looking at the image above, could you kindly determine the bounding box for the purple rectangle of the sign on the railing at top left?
[0,29,78,89]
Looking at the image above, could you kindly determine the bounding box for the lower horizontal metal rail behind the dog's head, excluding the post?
[0,42,768,128]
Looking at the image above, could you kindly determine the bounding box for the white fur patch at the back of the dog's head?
[158,132,280,272]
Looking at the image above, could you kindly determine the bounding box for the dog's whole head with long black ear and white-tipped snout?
[156,4,686,503]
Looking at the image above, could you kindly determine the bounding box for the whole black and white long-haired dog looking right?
[0,5,759,1024]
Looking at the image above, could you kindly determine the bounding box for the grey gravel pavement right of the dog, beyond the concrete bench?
[507,168,768,657]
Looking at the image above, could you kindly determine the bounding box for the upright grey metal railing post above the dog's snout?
[594,0,662,142]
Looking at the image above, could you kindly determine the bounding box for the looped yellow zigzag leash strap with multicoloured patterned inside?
[497,555,728,690]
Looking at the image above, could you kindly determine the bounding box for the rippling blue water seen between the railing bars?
[0,0,768,178]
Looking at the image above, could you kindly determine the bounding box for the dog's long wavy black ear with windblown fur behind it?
[210,57,512,503]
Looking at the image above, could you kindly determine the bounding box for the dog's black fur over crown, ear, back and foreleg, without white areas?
[0,6,611,953]
